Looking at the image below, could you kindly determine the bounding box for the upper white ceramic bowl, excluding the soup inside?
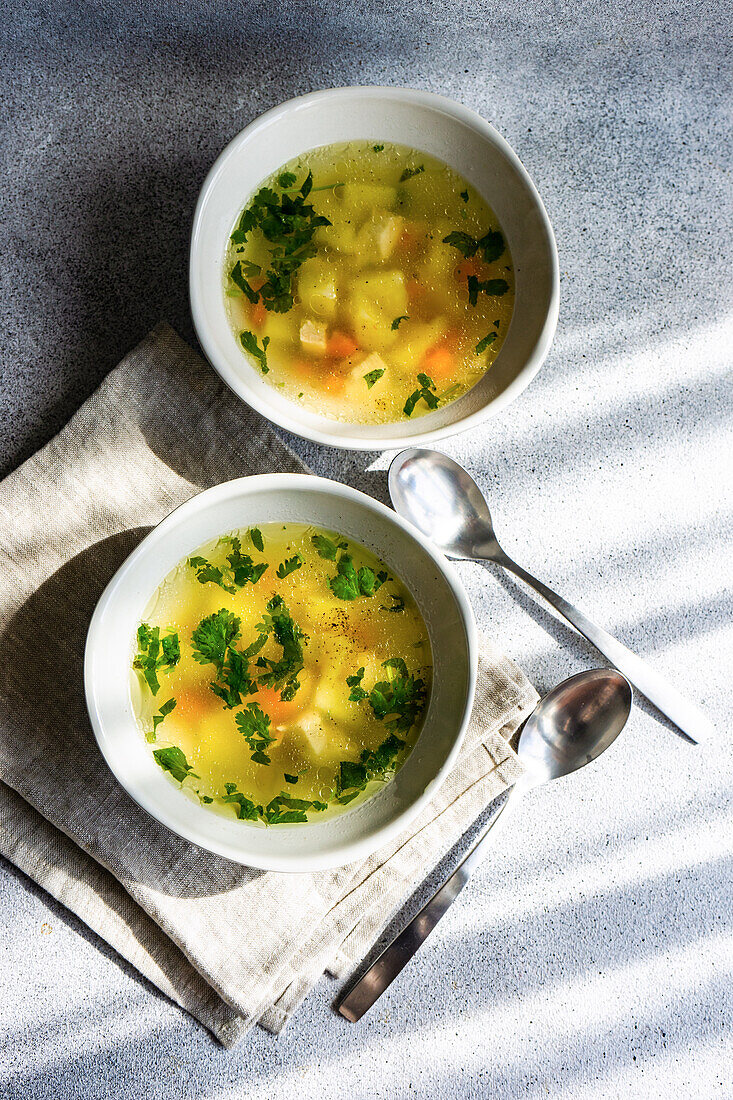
[189,87,559,450]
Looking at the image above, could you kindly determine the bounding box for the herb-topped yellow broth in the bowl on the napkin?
[131,524,433,825]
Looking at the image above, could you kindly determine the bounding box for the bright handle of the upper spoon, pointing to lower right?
[492,553,714,743]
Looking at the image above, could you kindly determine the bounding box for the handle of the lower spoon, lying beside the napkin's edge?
[338,788,521,1023]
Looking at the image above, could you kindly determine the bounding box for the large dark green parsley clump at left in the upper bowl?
[230,172,331,314]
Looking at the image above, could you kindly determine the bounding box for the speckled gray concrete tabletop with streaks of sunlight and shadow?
[0,0,733,1100]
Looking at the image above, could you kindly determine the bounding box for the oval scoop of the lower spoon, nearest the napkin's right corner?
[517,669,632,787]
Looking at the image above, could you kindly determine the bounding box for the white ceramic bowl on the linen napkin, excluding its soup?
[84,474,477,871]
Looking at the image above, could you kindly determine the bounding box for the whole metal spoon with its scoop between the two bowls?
[390,450,713,741]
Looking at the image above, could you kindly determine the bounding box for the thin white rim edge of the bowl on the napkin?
[84,473,479,872]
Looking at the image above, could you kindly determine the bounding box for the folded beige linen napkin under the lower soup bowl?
[0,326,537,1045]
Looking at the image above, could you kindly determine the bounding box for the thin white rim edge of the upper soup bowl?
[188,85,560,451]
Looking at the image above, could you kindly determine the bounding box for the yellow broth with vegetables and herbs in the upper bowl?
[225,142,514,424]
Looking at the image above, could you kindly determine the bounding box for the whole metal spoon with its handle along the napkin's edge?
[339,669,632,1022]
